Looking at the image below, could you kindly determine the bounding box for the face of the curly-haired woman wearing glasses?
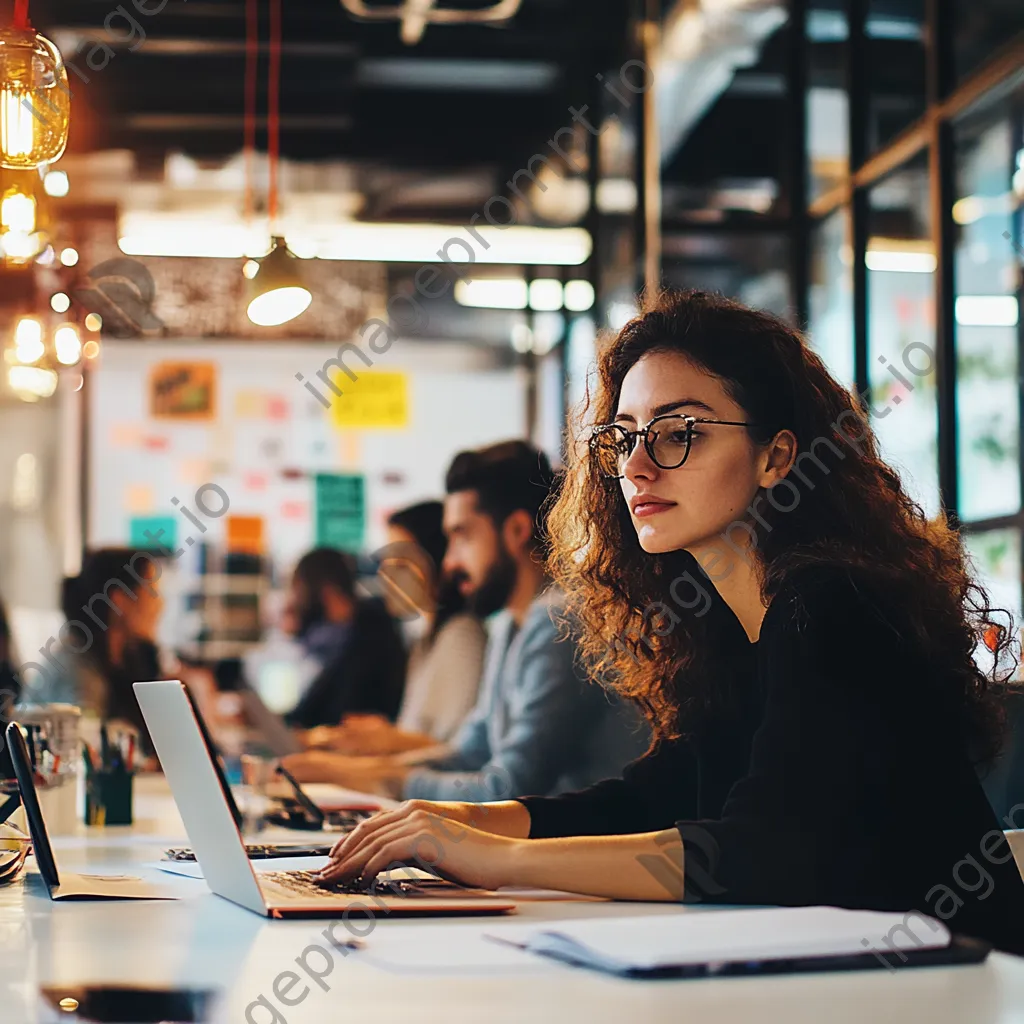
[615,351,792,564]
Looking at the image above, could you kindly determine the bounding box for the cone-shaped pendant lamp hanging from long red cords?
[246,0,313,327]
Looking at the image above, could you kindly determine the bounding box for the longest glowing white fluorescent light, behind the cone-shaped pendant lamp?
[118,211,592,266]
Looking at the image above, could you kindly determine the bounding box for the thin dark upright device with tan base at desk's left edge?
[6,722,177,900]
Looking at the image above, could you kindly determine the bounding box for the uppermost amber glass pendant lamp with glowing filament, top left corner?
[0,0,71,170]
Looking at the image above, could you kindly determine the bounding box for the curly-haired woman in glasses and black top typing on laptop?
[325,293,1024,952]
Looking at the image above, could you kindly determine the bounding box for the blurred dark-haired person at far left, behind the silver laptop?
[22,548,168,757]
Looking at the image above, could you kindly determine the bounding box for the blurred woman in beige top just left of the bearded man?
[308,502,487,755]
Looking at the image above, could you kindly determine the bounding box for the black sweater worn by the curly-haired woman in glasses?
[523,568,1024,953]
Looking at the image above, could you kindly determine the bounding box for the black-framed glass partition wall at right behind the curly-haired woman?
[790,0,1024,626]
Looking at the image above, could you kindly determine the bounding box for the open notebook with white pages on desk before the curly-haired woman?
[487,906,991,978]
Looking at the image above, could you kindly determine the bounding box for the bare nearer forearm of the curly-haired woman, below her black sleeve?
[501,827,684,900]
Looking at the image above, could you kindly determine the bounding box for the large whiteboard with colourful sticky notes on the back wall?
[87,339,526,572]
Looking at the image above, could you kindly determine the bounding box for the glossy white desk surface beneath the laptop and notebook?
[6,779,1024,1024]
